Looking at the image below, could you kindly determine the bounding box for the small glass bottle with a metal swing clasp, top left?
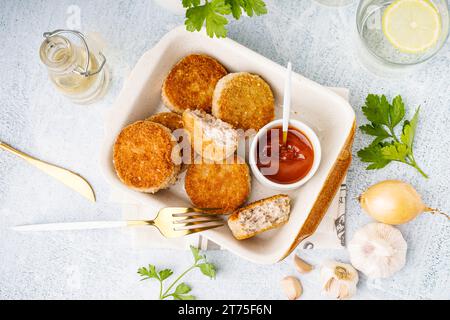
[40,30,109,104]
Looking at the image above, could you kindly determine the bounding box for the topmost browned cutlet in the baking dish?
[162,54,228,114]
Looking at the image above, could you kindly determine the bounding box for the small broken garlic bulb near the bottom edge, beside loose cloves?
[320,261,359,299]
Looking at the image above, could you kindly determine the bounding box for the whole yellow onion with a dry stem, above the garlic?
[359,180,431,225]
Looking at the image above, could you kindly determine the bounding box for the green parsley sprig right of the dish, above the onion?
[358,94,428,178]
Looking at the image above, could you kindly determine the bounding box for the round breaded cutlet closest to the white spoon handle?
[212,72,275,131]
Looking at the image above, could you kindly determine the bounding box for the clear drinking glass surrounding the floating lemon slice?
[356,0,449,68]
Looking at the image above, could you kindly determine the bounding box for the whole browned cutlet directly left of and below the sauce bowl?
[185,156,251,214]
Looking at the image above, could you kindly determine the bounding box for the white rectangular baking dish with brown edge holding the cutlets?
[101,27,355,264]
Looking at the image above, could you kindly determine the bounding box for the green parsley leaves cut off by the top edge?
[182,0,267,38]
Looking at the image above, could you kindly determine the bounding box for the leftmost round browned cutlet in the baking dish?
[113,121,180,193]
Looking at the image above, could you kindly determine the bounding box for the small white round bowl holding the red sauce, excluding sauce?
[249,119,322,191]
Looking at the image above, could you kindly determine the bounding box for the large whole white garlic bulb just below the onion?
[348,223,408,278]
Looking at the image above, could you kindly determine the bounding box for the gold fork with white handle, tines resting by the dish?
[12,208,224,238]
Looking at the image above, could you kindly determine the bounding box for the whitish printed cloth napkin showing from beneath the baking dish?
[110,88,349,250]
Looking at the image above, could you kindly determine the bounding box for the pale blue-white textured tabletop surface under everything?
[0,0,450,299]
